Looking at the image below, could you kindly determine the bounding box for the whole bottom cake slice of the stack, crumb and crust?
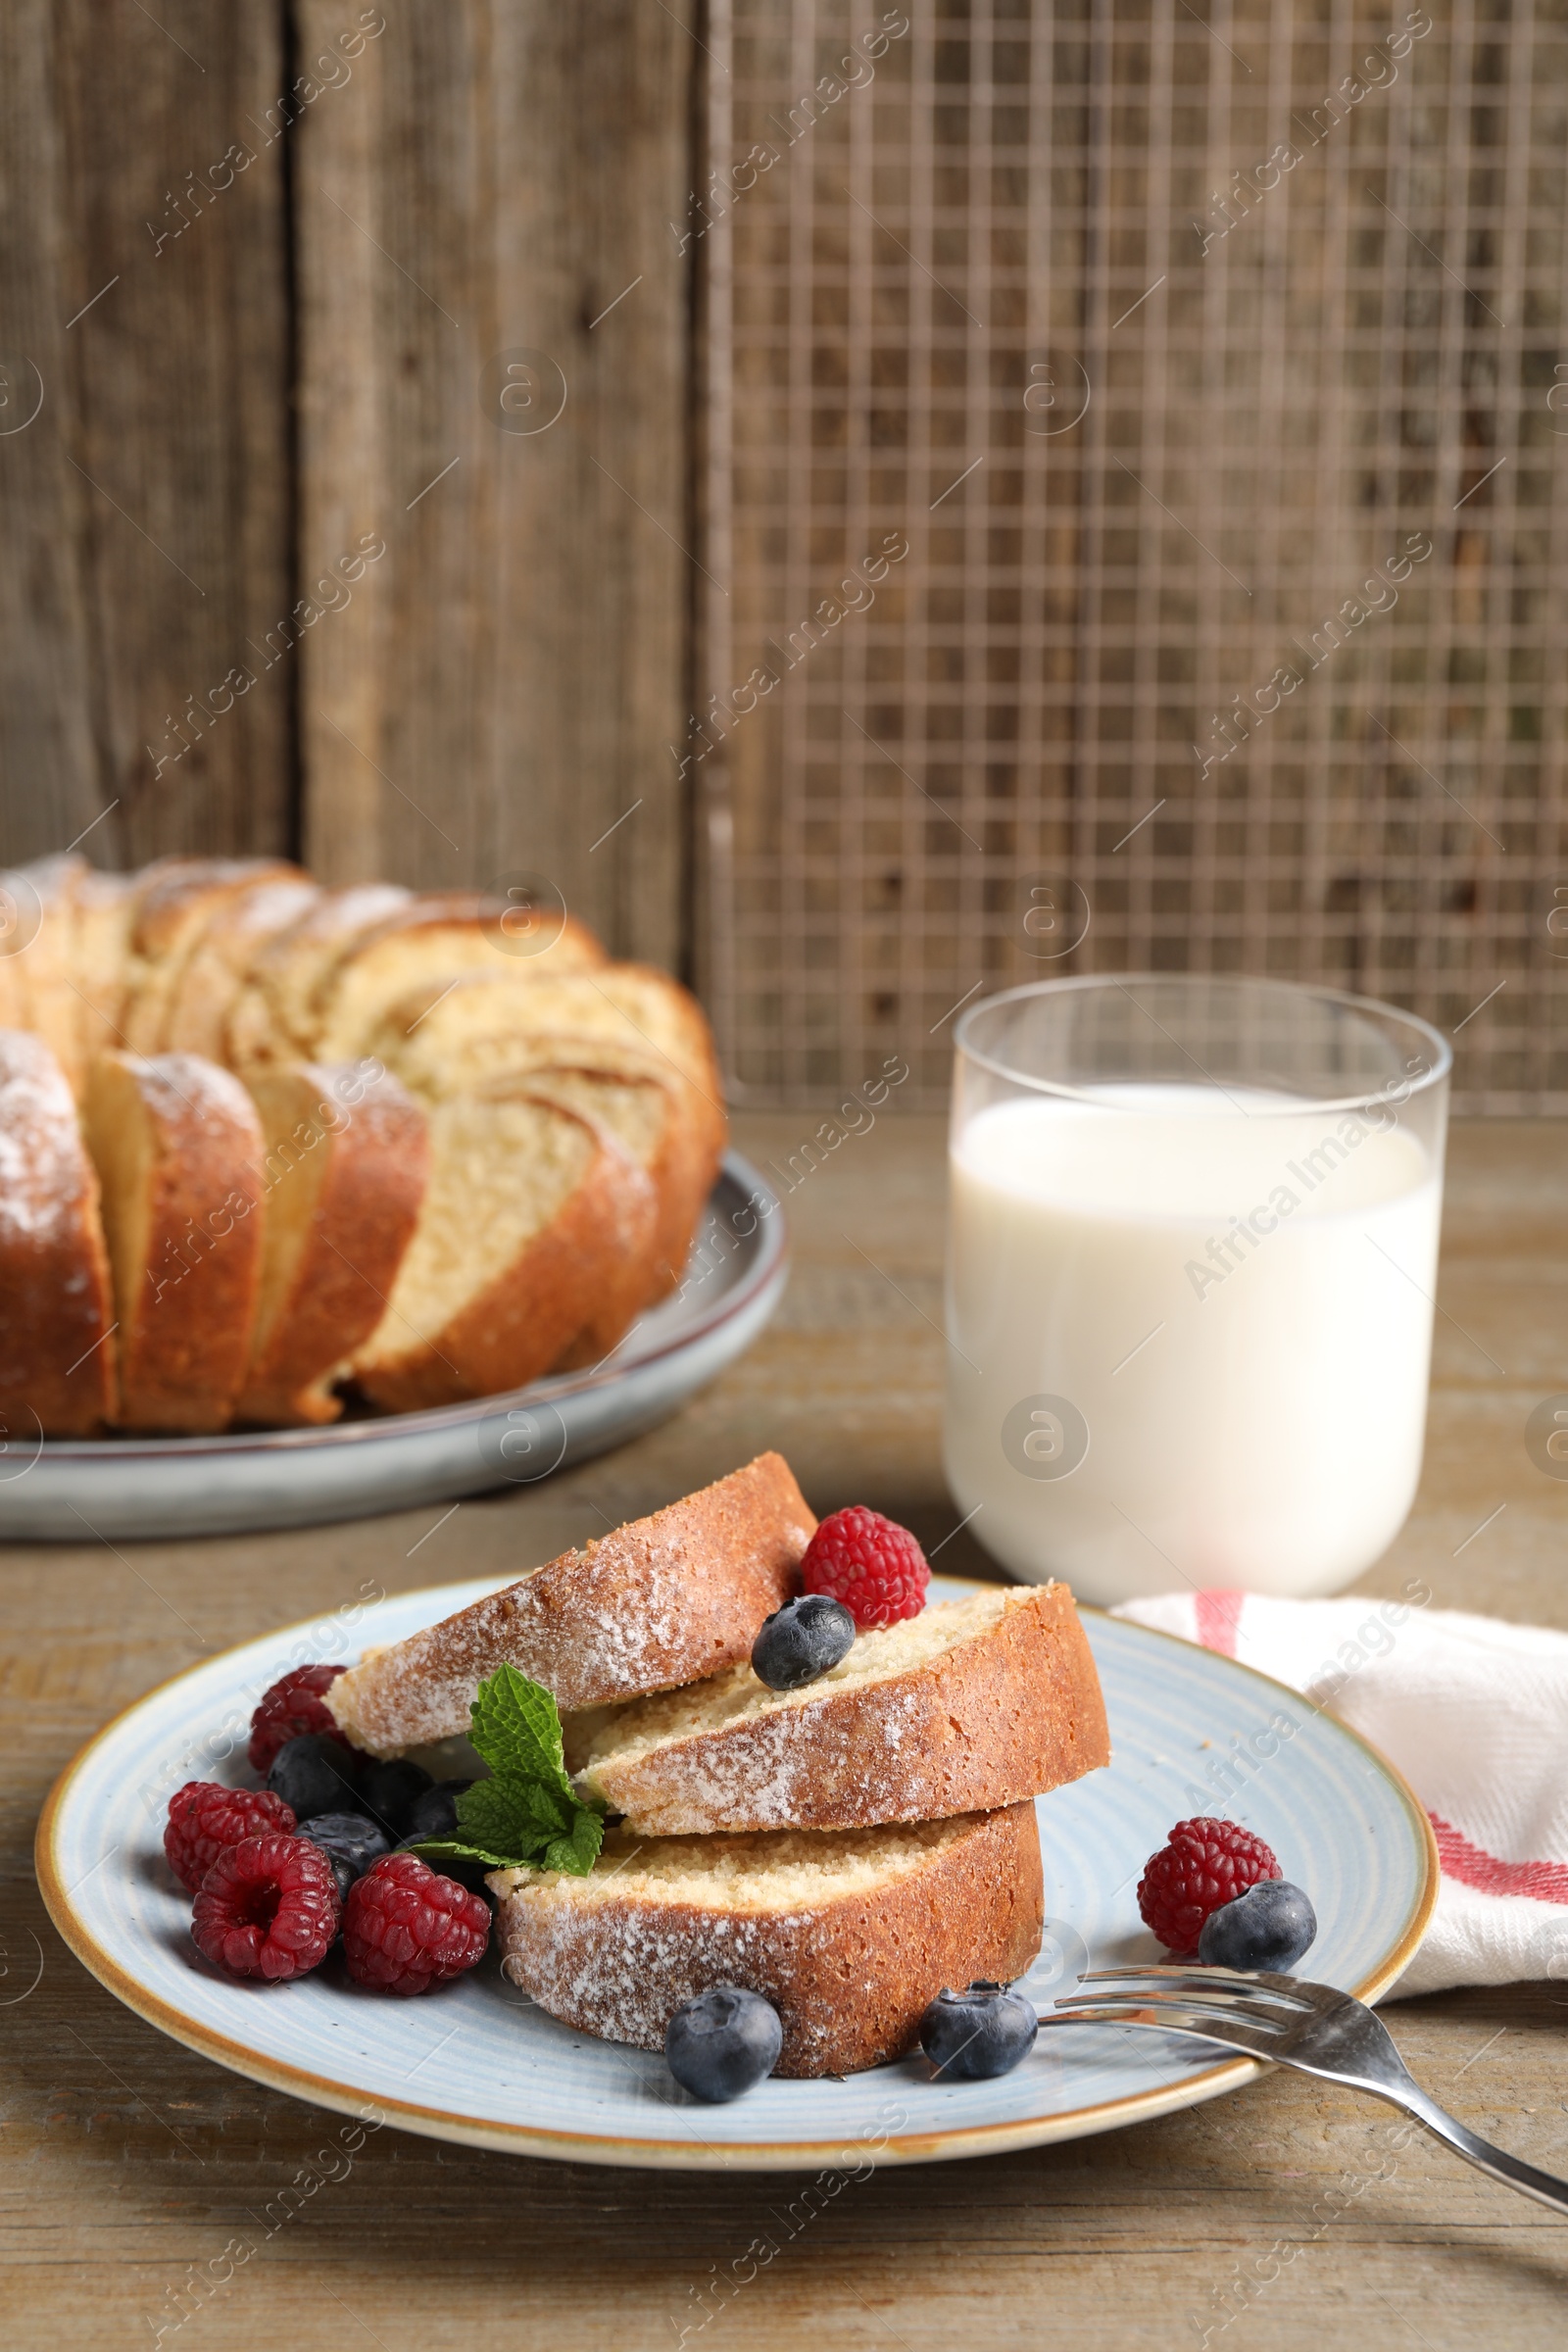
[489,1804,1044,2077]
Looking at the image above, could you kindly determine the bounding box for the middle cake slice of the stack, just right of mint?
[578,1586,1109,1837]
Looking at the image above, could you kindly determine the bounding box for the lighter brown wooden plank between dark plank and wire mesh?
[296,0,694,964]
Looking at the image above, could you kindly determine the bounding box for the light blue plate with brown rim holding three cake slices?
[37,1578,1439,2169]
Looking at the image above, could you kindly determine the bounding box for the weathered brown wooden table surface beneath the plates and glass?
[0,1112,1568,2352]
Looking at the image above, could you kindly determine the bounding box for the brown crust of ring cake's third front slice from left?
[235,1063,430,1425]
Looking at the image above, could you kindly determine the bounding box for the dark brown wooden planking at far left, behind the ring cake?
[0,0,291,863]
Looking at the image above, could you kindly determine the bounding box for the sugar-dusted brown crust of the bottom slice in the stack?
[491,1804,1044,2077]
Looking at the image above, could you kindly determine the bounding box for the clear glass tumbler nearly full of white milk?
[945,976,1450,1601]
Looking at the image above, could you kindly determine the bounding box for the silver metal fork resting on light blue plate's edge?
[1039,1966,1568,2213]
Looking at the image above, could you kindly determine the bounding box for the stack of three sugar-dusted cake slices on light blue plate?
[326,1453,1109,2077]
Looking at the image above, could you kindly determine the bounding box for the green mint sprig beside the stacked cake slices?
[418,1665,604,1880]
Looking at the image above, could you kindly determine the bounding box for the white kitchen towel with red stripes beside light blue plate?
[1112,1578,1568,1999]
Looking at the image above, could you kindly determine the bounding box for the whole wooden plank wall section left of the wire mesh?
[0,0,696,962]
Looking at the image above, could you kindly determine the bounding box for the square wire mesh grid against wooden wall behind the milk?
[700,0,1568,1112]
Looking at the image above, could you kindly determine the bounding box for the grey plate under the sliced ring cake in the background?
[0,1152,788,1543]
